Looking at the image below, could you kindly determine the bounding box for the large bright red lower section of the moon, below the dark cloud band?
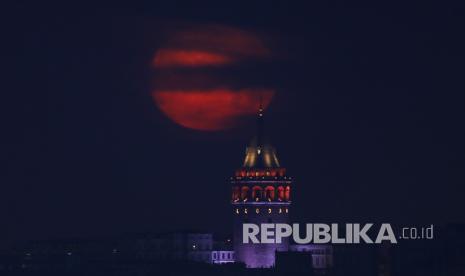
[153,89,273,131]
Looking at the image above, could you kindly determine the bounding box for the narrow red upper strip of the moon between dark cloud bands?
[154,49,233,67]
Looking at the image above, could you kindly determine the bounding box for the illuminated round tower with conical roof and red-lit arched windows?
[231,108,292,268]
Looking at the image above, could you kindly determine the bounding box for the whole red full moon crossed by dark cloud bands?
[152,25,274,131]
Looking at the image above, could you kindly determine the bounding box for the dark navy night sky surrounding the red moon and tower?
[0,1,465,248]
